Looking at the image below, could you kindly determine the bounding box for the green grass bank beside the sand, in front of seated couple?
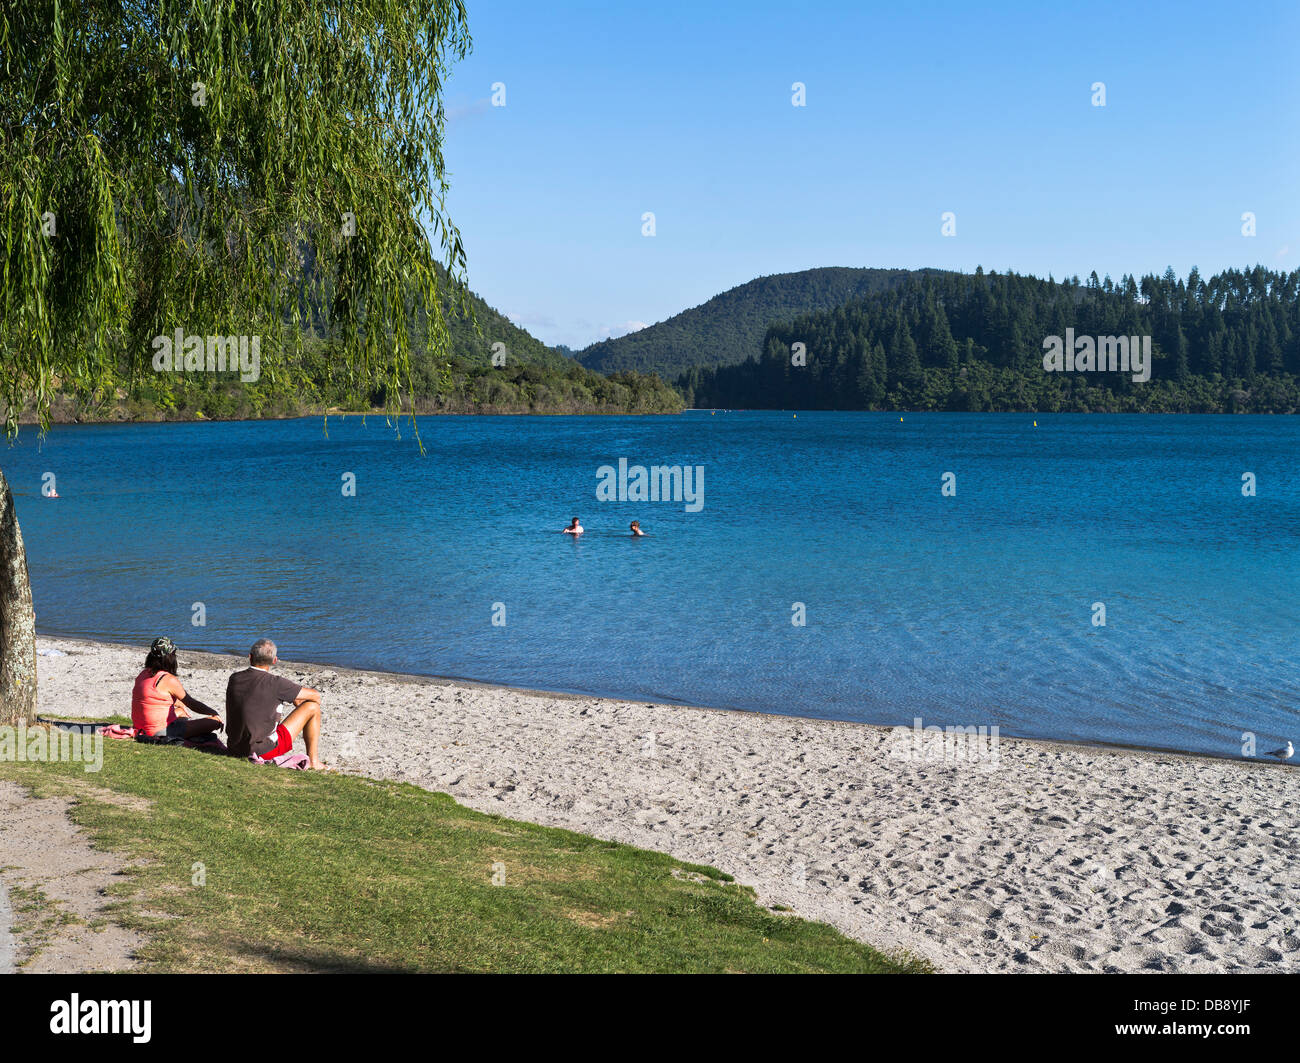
[0,742,926,972]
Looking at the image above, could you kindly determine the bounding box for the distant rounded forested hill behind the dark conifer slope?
[577,266,937,379]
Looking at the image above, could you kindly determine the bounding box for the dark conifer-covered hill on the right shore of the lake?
[677,266,1300,413]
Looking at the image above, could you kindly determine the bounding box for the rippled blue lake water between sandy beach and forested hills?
[0,412,1300,755]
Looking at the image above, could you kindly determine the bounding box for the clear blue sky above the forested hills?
[446,0,1300,347]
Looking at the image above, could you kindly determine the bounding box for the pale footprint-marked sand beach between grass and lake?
[30,638,1300,972]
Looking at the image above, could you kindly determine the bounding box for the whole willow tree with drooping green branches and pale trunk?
[0,0,469,721]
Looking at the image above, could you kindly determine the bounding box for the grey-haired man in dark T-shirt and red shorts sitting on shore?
[226,638,325,771]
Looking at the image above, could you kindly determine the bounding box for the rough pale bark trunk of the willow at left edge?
[0,472,36,724]
